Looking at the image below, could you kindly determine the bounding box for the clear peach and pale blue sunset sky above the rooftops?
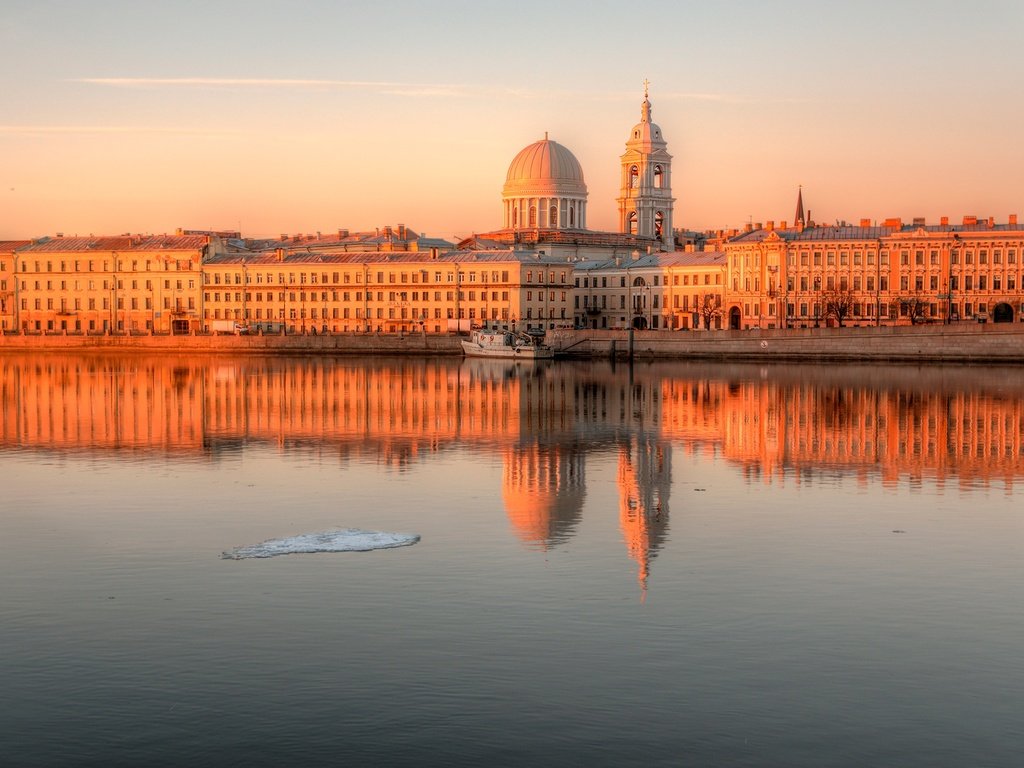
[0,0,1024,239]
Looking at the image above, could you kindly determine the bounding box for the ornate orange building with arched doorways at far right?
[723,215,1024,329]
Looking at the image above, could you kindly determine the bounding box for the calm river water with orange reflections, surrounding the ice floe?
[0,355,1024,767]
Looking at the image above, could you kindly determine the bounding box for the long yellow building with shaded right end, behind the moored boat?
[202,249,572,333]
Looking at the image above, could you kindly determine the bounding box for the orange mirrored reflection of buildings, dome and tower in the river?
[0,354,1024,589]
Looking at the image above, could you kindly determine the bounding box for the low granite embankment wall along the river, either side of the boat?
[6,324,1024,364]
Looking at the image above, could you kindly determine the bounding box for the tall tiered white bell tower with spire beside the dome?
[617,80,676,251]
